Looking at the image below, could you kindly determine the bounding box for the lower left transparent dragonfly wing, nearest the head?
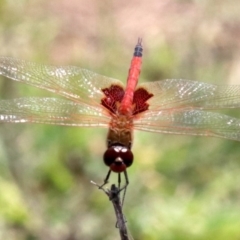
[0,97,110,127]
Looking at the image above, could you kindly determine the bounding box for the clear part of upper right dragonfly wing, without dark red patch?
[139,79,240,112]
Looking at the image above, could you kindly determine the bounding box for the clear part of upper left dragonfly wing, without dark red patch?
[0,57,122,105]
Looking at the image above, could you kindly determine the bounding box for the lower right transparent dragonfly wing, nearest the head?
[134,109,240,141]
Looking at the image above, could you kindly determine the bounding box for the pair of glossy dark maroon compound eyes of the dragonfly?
[103,146,133,167]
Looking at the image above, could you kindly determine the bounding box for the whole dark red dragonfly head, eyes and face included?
[103,145,133,172]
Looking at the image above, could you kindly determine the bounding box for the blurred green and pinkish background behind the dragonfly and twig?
[0,0,240,240]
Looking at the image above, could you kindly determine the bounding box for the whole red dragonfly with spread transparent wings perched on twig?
[0,39,240,189]
